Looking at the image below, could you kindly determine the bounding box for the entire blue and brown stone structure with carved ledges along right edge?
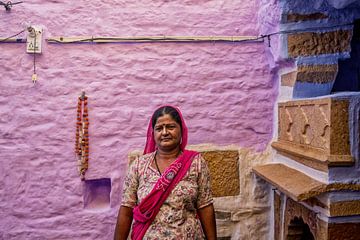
[254,0,360,239]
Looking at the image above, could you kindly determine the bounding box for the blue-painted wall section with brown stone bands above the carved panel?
[280,1,360,100]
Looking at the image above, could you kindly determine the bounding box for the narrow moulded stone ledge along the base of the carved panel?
[271,141,354,171]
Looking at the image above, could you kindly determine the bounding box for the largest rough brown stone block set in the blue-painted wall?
[287,30,352,58]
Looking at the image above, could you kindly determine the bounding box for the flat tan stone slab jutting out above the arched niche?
[253,164,326,201]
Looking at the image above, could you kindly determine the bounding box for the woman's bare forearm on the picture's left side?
[114,206,133,240]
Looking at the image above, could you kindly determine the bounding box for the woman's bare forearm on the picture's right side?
[197,204,216,240]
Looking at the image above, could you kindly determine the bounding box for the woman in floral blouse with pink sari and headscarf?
[114,105,216,240]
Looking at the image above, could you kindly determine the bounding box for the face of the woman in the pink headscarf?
[154,114,181,151]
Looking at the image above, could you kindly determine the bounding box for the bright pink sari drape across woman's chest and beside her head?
[131,107,198,240]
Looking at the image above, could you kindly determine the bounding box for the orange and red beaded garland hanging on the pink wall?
[75,92,89,180]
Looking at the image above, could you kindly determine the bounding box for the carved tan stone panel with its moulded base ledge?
[272,98,353,170]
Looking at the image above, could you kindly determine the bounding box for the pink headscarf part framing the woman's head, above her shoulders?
[144,105,188,154]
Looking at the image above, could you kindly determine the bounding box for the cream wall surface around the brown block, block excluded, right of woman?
[202,146,271,240]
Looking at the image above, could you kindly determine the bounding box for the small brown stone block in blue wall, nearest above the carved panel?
[296,64,338,83]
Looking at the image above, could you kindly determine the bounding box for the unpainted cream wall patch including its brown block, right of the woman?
[198,145,271,240]
